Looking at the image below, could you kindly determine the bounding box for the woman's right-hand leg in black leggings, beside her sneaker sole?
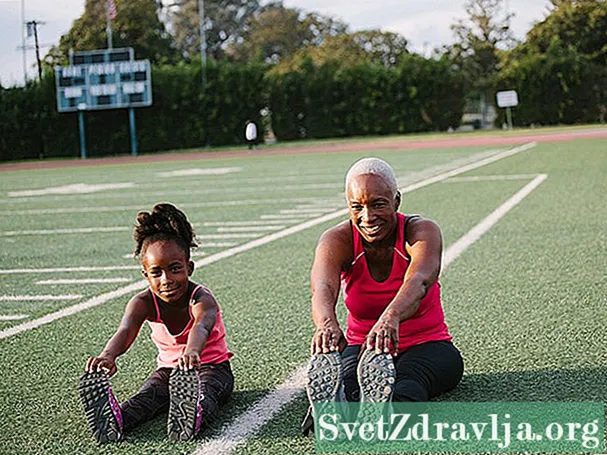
[393,341,464,401]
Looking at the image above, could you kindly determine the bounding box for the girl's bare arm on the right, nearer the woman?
[178,288,219,370]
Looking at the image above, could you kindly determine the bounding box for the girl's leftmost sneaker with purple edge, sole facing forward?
[79,373,122,443]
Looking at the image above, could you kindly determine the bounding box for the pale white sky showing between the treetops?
[0,0,550,87]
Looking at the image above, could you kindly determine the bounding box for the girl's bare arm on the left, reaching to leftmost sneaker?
[86,295,149,376]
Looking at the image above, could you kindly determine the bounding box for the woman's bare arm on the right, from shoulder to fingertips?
[366,218,443,353]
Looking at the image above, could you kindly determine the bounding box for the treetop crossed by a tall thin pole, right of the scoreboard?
[169,0,260,61]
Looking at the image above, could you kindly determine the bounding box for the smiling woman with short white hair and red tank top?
[302,158,463,433]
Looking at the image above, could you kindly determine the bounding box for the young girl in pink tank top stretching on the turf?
[80,204,234,442]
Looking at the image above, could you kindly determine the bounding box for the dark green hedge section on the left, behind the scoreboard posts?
[0,60,266,161]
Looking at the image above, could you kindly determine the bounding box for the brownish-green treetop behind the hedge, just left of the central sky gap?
[228,3,347,64]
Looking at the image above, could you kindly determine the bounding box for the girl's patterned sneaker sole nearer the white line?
[167,368,203,442]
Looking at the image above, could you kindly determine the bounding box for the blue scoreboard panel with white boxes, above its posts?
[55,48,152,112]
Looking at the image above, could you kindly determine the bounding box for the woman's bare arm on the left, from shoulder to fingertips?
[310,223,351,354]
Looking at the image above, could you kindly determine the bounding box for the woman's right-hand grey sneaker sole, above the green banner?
[356,350,396,403]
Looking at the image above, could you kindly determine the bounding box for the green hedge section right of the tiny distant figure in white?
[267,55,464,140]
